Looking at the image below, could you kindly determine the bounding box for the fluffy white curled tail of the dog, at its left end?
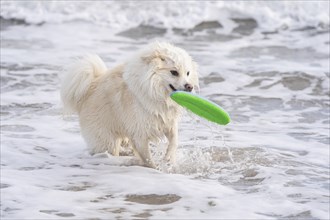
[61,55,107,113]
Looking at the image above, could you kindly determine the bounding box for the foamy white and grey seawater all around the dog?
[0,1,330,220]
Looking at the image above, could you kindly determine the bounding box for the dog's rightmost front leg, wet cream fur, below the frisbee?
[165,122,178,164]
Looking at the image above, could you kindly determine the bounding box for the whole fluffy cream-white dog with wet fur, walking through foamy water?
[61,42,198,168]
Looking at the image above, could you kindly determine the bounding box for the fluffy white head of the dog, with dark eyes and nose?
[124,42,199,104]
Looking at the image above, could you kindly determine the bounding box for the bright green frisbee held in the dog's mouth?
[171,91,230,125]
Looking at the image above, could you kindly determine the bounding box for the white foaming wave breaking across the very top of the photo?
[0,1,329,31]
